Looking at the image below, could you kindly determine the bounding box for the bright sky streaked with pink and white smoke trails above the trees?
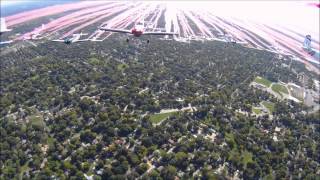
[2,0,320,63]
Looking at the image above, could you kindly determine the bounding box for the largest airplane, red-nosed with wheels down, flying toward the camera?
[99,22,177,43]
